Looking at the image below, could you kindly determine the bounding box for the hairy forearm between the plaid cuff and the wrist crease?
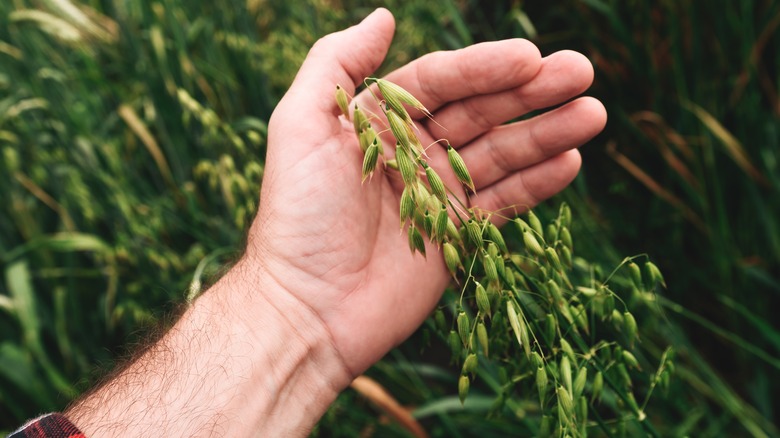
[66,262,351,436]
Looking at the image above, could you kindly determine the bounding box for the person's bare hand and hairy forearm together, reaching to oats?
[61,10,606,436]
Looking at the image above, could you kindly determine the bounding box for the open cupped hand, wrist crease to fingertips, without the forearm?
[247,9,606,375]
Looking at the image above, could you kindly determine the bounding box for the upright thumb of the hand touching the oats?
[283,8,395,119]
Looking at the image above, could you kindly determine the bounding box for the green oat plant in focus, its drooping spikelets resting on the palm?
[336,78,674,436]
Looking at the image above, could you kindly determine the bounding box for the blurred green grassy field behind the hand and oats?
[0,0,780,436]
